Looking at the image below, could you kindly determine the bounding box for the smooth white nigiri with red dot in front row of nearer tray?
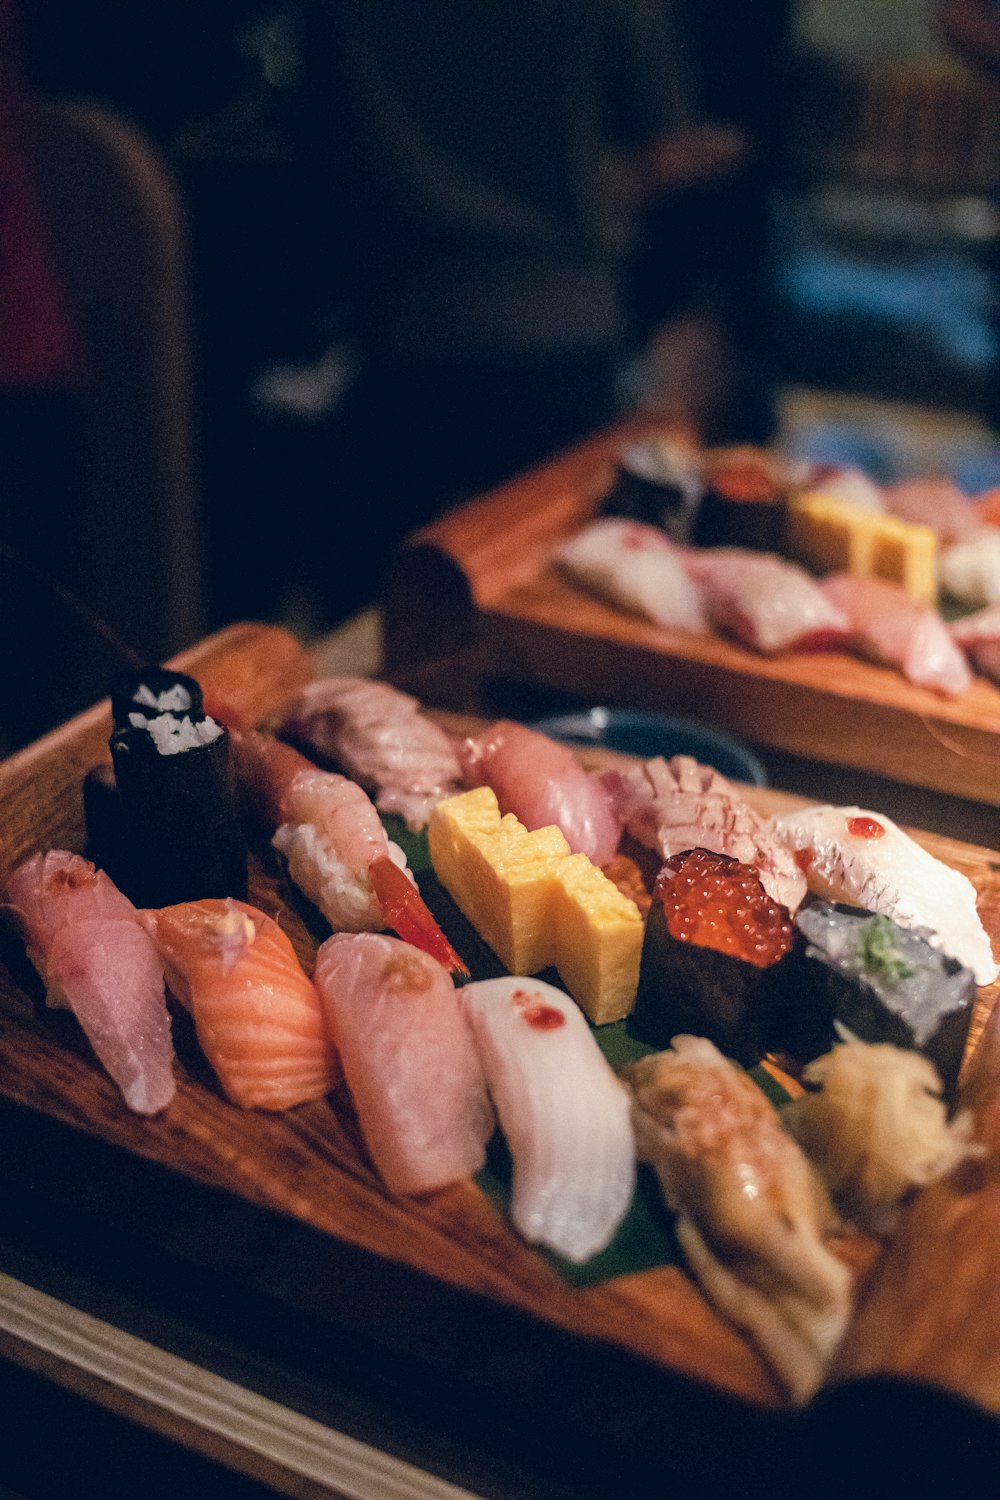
[460,978,636,1263]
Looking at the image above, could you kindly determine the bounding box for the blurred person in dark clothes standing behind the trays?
[296,0,742,570]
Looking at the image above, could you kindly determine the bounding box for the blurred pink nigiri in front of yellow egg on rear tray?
[822,573,972,698]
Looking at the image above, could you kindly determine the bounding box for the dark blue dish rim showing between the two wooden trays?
[531,708,768,786]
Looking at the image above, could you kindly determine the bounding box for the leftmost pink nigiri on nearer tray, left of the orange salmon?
[6,849,174,1115]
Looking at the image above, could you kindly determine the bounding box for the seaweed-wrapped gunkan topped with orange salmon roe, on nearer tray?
[630,849,793,1064]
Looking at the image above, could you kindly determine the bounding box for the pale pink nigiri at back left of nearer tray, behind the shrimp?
[279,677,462,830]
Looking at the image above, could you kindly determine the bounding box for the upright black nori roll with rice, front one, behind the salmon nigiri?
[111,710,247,906]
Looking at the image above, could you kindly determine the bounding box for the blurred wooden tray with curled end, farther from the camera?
[385,423,1000,807]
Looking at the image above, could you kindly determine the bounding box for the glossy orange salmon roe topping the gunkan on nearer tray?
[654,849,793,969]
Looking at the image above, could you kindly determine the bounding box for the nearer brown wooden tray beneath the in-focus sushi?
[0,626,1000,1493]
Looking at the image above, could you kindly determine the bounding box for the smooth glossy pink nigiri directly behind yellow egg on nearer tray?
[459,719,622,866]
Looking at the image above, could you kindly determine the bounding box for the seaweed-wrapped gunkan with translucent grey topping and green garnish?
[780,902,976,1095]
